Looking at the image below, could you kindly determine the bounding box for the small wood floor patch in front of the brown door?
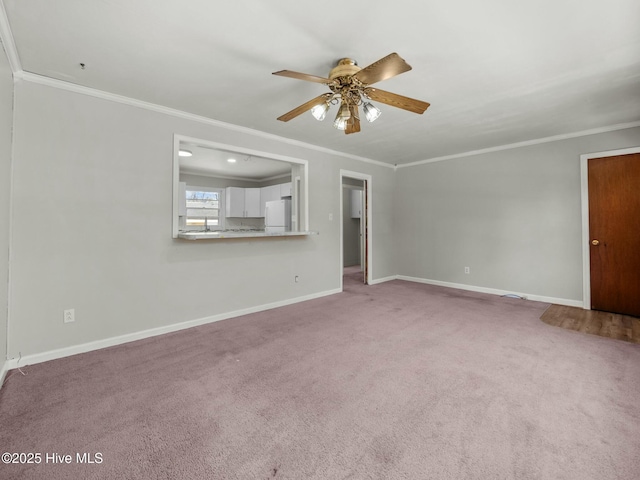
[540,305,640,344]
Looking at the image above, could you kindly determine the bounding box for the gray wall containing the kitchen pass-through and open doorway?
[8,81,395,358]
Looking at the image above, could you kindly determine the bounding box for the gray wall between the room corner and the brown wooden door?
[394,128,640,301]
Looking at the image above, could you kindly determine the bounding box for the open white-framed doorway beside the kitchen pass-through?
[340,170,371,288]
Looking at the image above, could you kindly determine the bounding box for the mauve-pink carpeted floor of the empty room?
[0,276,640,480]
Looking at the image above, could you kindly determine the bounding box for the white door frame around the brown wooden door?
[580,147,640,310]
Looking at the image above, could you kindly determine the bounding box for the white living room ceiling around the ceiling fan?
[2,0,640,164]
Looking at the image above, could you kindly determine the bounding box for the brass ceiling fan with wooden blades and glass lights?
[273,53,429,135]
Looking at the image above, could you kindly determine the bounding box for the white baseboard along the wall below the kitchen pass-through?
[3,289,340,372]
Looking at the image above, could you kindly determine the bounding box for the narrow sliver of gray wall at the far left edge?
[0,44,13,367]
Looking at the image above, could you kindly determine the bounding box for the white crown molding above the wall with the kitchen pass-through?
[15,71,394,169]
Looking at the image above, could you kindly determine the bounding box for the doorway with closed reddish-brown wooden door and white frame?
[581,148,640,316]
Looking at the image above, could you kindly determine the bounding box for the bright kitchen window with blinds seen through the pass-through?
[186,185,224,230]
